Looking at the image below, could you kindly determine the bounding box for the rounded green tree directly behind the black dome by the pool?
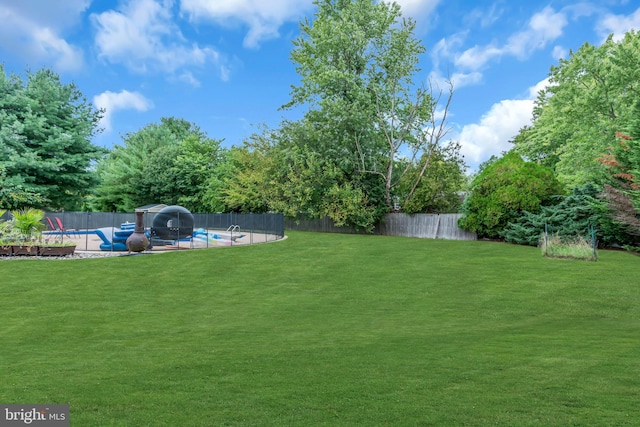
[96,118,221,212]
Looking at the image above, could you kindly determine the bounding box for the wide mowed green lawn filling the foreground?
[0,232,640,426]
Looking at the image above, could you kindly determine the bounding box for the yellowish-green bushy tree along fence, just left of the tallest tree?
[223,121,376,230]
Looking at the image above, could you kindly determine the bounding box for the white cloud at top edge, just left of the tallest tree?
[180,0,313,48]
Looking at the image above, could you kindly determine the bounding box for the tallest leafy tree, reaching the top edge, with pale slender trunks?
[284,0,453,217]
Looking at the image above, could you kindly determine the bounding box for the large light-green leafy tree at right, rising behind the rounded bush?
[514,31,640,185]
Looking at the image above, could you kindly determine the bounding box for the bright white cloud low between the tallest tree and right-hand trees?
[456,79,548,169]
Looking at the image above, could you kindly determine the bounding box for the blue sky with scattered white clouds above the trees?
[0,0,640,169]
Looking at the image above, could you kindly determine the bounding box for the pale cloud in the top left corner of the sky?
[0,0,88,72]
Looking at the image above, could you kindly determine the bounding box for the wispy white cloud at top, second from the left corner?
[91,0,225,77]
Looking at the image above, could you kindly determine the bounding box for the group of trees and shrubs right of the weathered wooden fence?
[460,31,640,248]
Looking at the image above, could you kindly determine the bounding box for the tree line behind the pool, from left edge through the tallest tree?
[0,0,465,230]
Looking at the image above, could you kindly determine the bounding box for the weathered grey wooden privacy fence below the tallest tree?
[285,213,478,240]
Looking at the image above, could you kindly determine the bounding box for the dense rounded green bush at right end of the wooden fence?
[458,152,562,238]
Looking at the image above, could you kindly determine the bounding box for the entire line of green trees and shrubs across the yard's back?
[0,0,640,246]
